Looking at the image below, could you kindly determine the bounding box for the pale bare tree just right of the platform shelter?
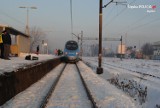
[30,27,45,52]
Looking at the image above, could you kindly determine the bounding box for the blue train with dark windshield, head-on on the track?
[64,40,80,63]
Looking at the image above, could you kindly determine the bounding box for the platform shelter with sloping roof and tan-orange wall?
[0,25,30,56]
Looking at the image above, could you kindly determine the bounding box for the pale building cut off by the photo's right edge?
[153,41,160,60]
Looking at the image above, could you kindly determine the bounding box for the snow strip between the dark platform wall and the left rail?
[0,64,64,108]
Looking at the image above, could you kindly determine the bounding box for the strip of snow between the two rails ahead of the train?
[46,64,91,108]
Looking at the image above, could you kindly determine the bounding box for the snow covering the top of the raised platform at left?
[0,53,56,74]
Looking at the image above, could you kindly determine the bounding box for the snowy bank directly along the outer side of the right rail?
[78,62,138,108]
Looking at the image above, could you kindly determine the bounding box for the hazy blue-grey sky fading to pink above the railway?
[0,0,160,52]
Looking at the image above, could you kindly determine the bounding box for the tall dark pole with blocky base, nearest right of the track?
[97,0,103,74]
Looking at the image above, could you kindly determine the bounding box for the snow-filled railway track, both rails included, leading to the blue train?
[40,64,98,108]
